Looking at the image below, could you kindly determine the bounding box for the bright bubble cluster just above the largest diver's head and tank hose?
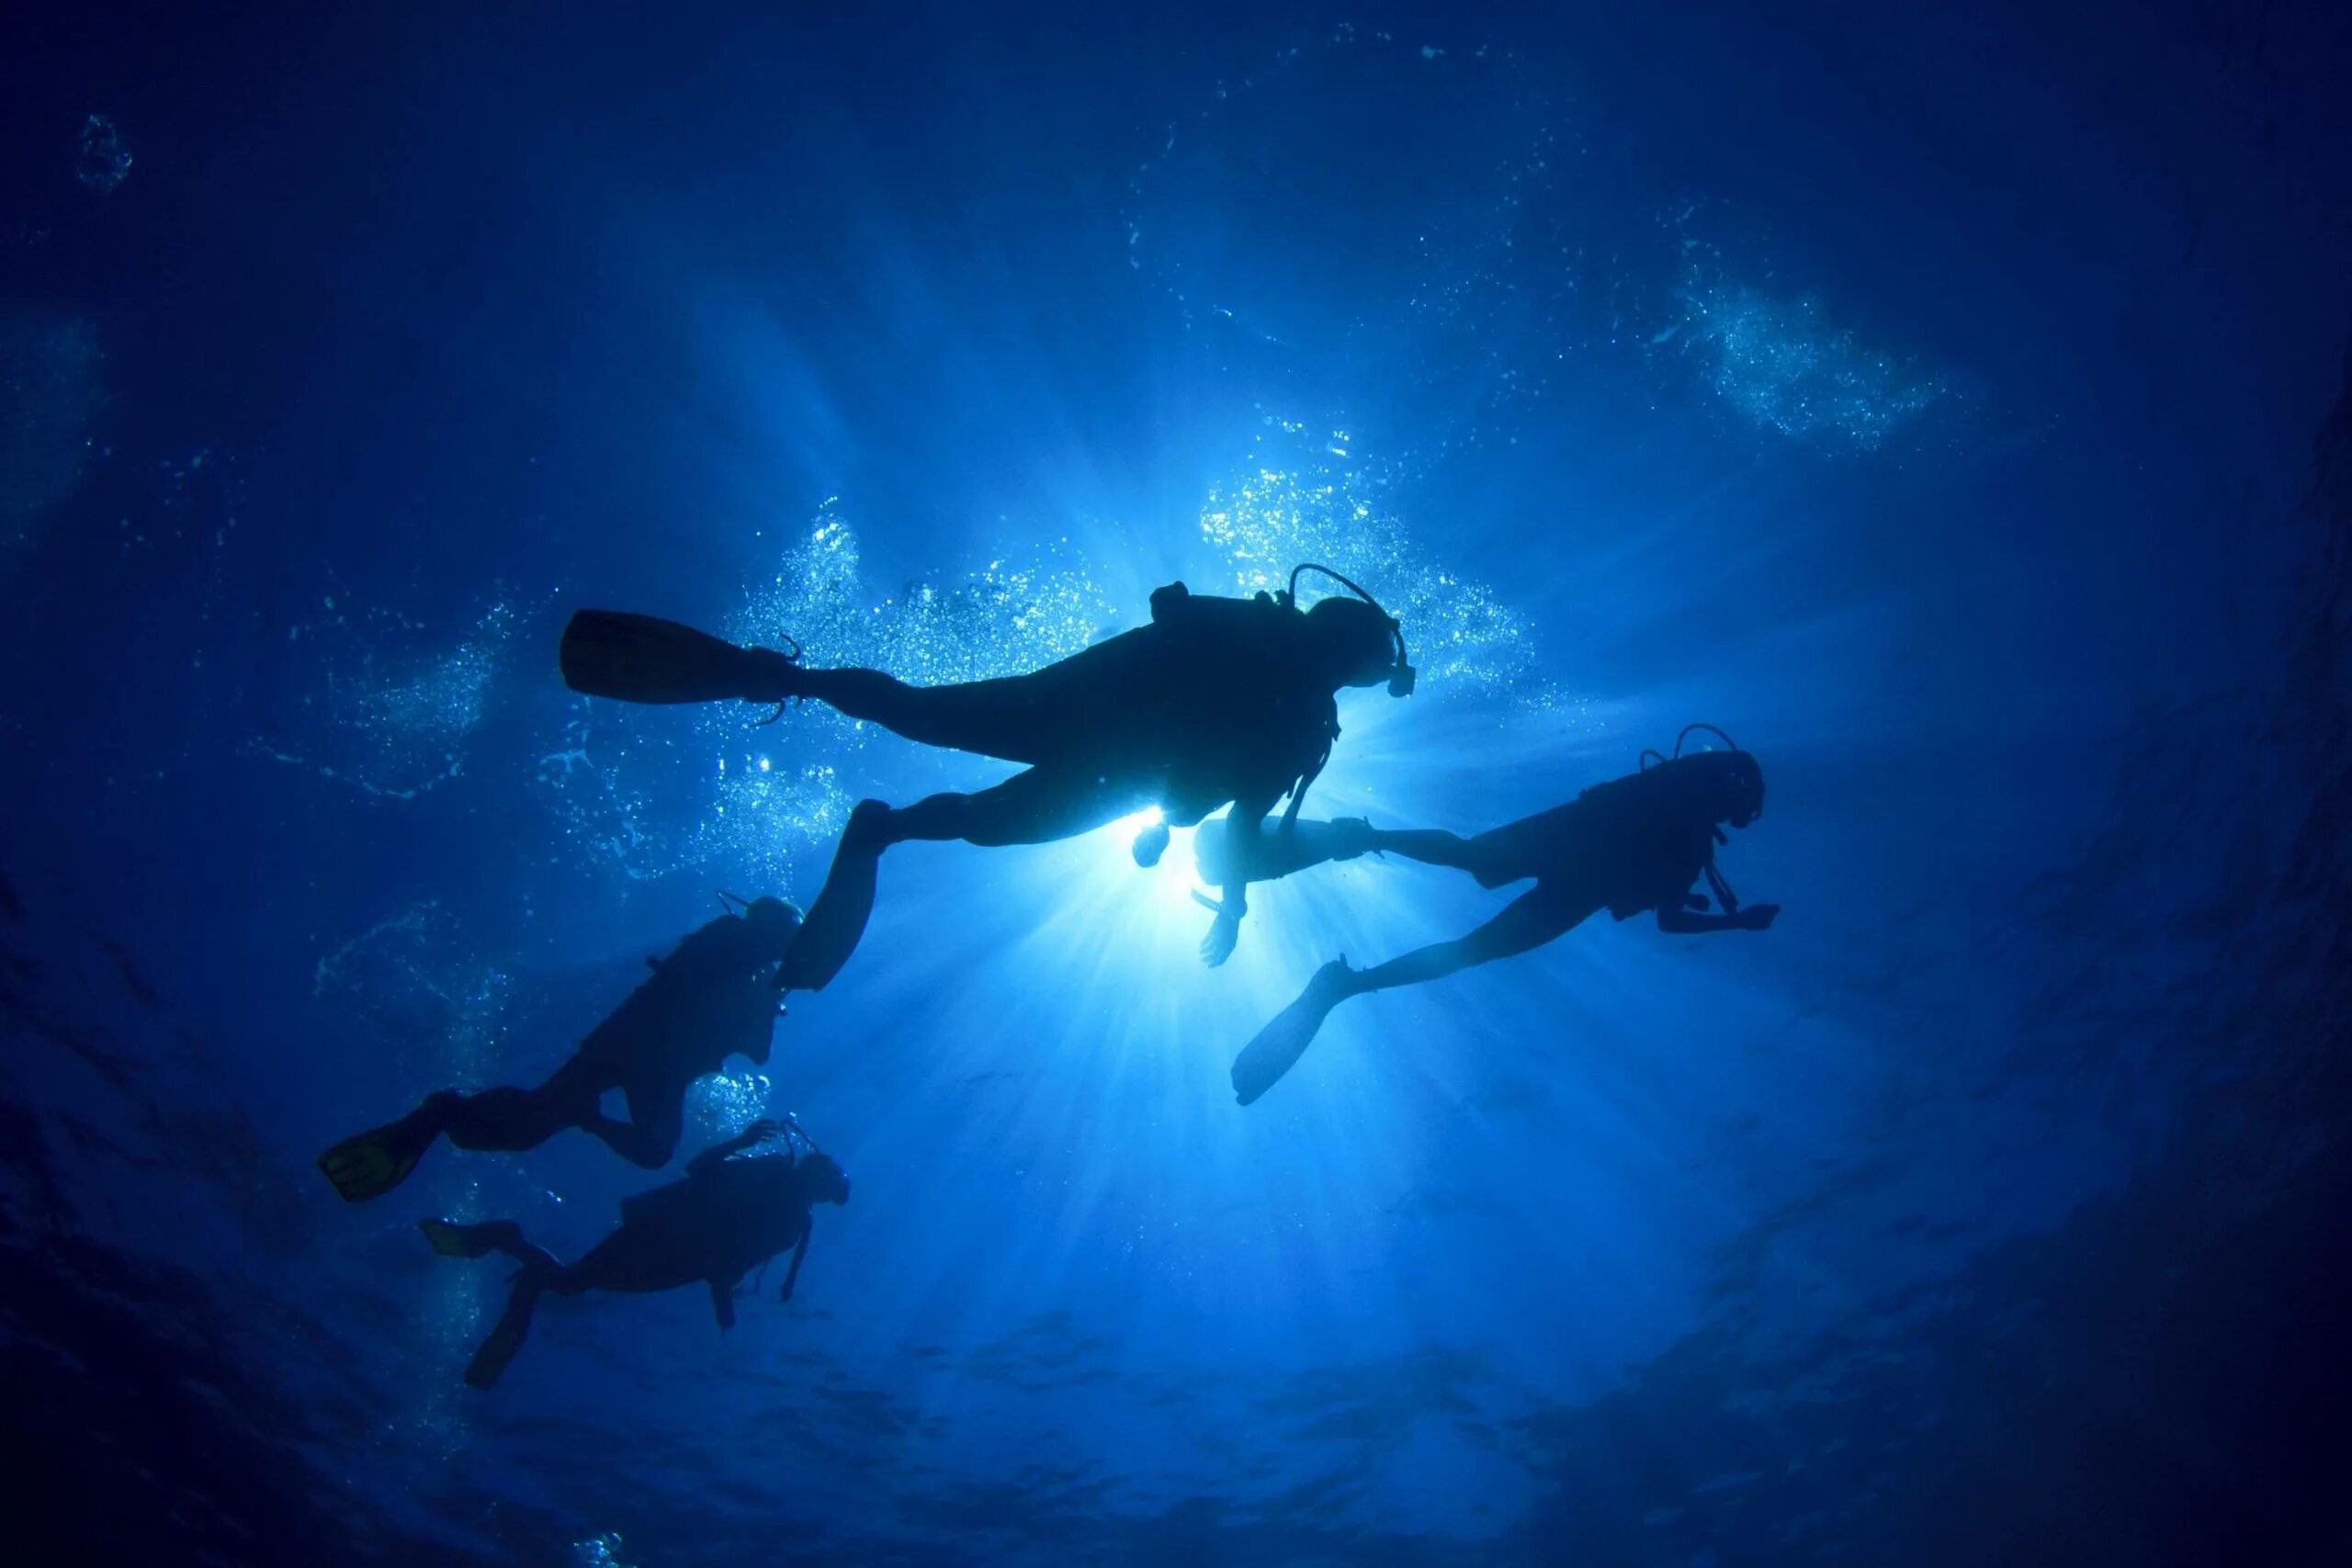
[1200,419,1553,703]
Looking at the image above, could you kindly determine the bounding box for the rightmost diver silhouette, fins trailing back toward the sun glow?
[1197,724,1781,1105]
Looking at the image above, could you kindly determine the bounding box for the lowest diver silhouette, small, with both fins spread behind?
[416,1119,849,1389]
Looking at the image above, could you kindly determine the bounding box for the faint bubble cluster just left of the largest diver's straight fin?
[249,594,515,799]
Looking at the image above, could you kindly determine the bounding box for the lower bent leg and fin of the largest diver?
[783,766,1159,989]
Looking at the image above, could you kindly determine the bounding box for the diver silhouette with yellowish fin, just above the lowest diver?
[318,894,799,1203]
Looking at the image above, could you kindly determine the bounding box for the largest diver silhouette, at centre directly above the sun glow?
[562,564,1414,987]
